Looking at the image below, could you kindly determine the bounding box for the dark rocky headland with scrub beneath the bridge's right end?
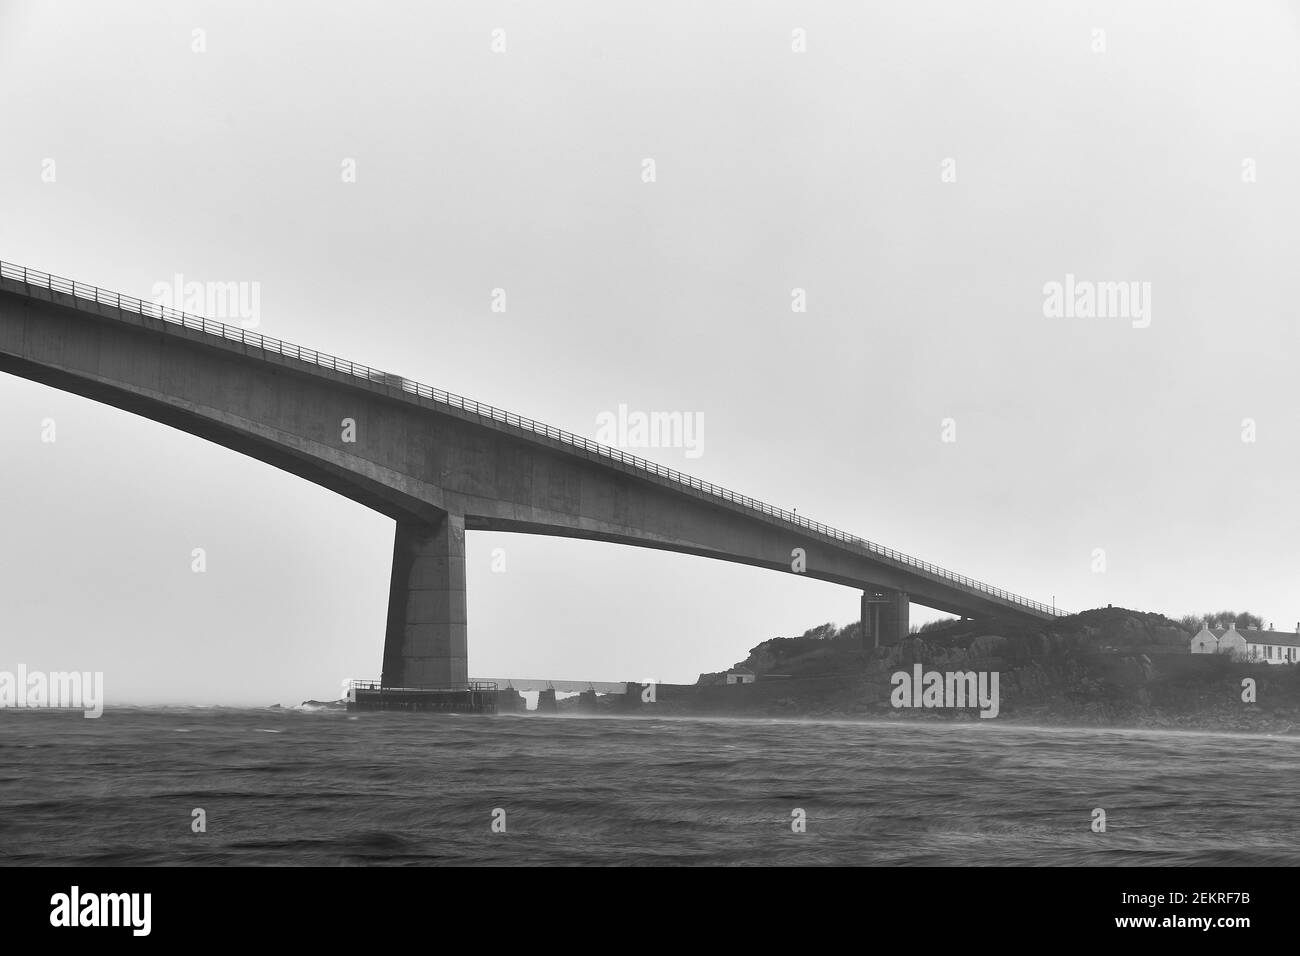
[683,607,1300,732]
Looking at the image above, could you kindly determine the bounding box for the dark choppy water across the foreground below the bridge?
[0,710,1300,865]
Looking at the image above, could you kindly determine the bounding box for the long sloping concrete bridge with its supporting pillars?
[0,263,1057,687]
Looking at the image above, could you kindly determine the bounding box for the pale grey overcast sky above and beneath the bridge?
[0,0,1300,705]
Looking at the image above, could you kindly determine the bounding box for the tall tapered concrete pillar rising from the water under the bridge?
[382,514,469,687]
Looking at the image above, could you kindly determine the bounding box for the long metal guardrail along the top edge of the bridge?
[0,260,1066,617]
